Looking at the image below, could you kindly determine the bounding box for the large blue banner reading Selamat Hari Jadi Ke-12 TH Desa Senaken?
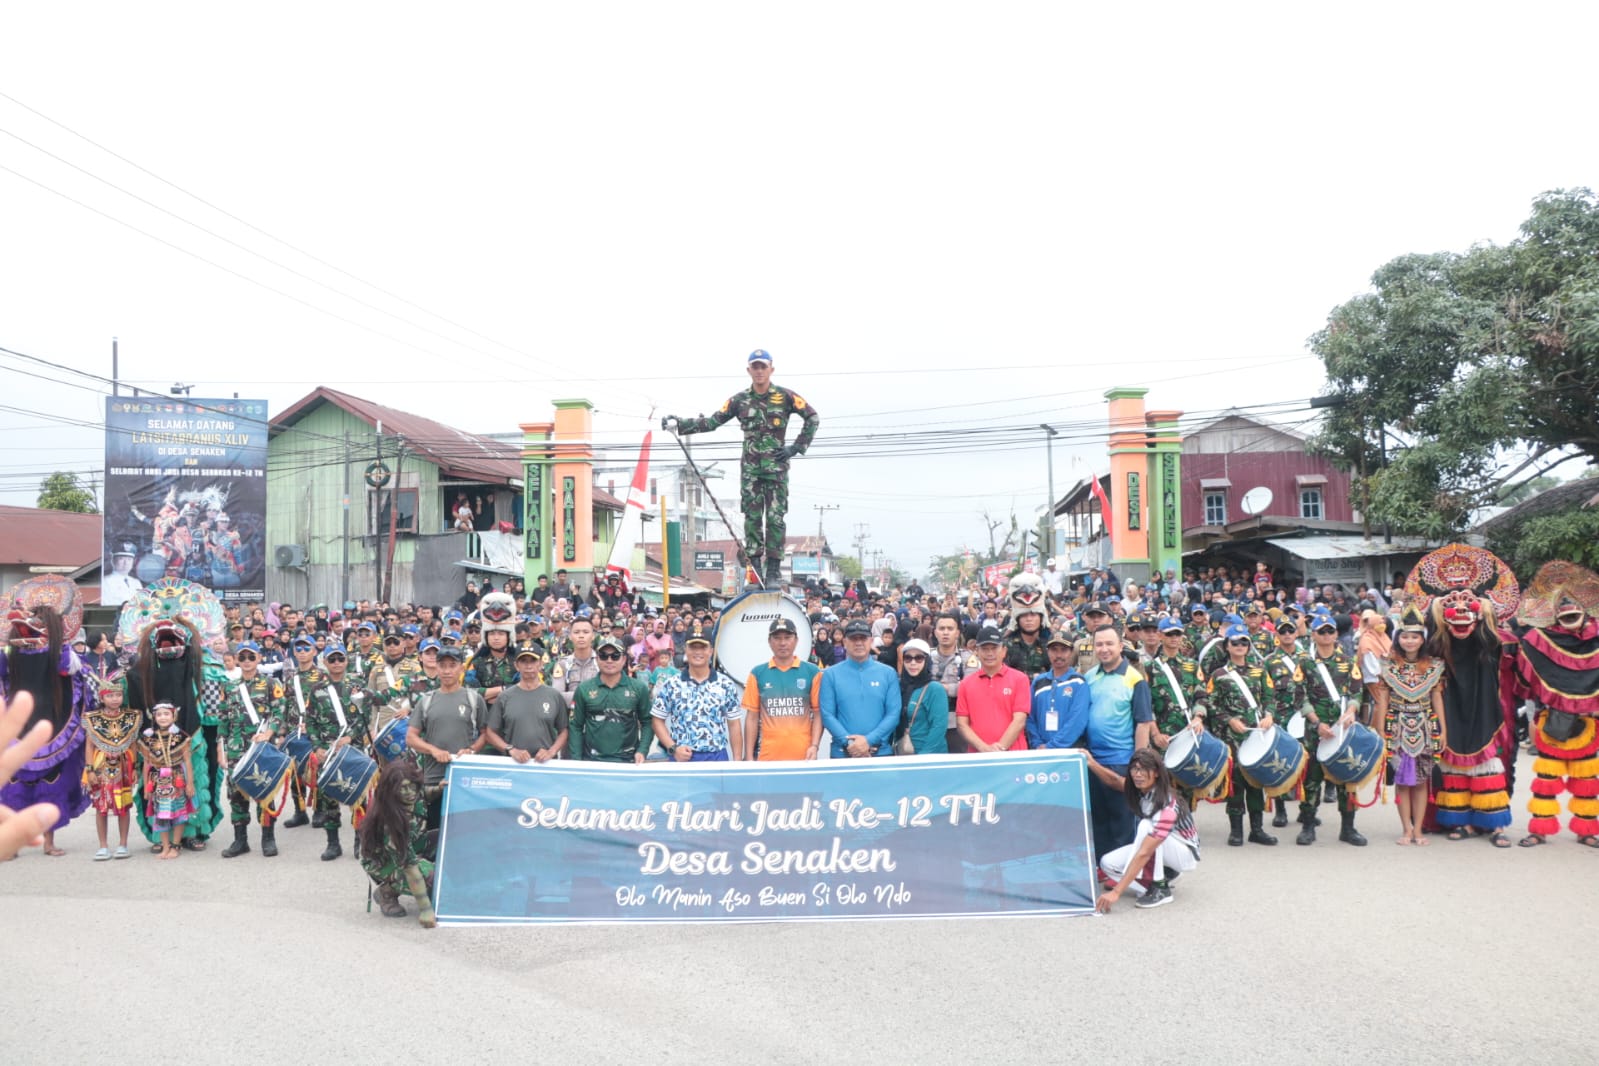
[433,751,1094,924]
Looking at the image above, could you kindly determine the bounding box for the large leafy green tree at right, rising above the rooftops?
[1310,189,1599,539]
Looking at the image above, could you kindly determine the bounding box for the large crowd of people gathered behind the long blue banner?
[9,549,1588,916]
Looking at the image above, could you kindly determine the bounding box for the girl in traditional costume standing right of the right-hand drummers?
[1375,607,1449,845]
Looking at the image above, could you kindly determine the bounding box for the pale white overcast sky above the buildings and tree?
[0,3,1599,584]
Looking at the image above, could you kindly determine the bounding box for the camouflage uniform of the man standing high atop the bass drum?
[678,384,822,575]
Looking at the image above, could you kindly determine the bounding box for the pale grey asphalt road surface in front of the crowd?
[0,747,1599,1066]
